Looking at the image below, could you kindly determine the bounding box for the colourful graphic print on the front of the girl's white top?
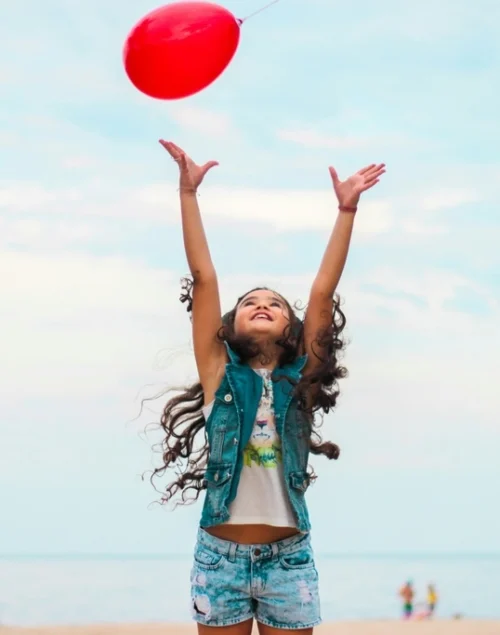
[243,370,281,468]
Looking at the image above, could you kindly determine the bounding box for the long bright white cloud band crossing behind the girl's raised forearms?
[0,175,492,244]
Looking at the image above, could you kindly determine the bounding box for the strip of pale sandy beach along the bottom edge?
[0,620,500,635]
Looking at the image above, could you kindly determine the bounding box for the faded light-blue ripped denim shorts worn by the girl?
[191,529,321,630]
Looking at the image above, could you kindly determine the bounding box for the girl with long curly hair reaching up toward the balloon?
[153,141,385,635]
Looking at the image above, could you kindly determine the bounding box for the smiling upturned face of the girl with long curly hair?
[234,289,290,339]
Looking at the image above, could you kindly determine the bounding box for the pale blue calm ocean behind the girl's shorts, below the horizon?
[0,555,500,626]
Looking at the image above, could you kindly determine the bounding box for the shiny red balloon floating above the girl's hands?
[123,2,241,99]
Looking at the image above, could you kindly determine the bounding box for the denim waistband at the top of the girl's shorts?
[198,527,311,560]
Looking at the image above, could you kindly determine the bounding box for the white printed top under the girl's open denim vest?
[203,368,297,527]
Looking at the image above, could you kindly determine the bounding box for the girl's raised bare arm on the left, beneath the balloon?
[160,140,226,403]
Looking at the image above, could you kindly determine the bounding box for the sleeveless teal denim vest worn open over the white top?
[200,345,311,532]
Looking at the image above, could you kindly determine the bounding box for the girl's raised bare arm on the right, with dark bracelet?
[304,163,385,373]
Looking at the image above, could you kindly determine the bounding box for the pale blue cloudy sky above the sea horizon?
[0,0,500,554]
